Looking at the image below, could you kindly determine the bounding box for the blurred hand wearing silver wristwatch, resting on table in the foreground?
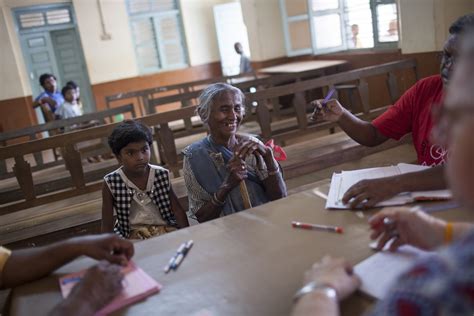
[305,256,360,300]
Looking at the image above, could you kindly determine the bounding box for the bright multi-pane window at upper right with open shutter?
[280,0,398,56]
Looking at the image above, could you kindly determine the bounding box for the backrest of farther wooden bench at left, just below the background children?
[0,104,136,179]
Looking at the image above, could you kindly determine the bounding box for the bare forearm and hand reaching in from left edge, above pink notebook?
[0,234,133,288]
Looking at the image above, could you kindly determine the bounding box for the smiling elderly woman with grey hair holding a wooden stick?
[183,83,286,222]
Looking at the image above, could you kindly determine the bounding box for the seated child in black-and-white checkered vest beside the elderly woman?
[102,120,189,239]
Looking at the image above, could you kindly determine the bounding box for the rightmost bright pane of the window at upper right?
[376,3,398,42]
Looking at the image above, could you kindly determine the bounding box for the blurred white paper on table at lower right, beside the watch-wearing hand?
[354,245,432,299]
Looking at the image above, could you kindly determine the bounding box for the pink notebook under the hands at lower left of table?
[59,261,162,316]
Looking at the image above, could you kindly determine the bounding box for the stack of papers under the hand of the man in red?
[326,163,452,209]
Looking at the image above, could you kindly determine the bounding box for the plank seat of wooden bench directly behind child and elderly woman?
[0,132,411,248]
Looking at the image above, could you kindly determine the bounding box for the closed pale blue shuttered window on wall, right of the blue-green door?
[127,0,187,73]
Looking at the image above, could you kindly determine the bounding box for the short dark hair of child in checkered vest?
[108,120,153,156]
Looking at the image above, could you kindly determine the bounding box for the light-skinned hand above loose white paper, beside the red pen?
[369,207,446,251]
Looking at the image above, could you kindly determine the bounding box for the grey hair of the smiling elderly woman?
[196,83,245,126]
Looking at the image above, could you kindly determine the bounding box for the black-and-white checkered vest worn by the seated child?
[104,165,176,238]
